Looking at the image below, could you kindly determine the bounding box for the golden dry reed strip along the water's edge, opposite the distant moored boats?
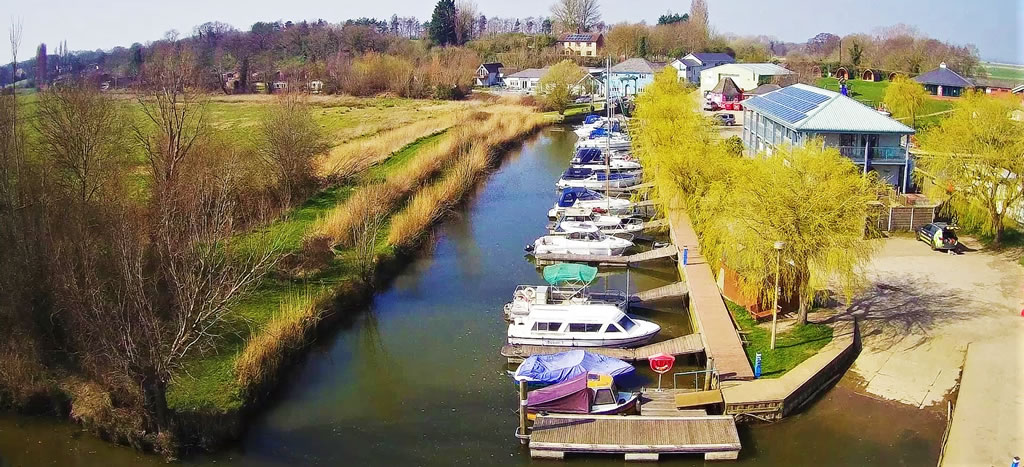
[388,112,549,248]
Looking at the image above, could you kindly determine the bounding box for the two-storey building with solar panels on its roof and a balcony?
[742,84,914,193]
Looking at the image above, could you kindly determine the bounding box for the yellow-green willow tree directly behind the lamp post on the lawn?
[702,141,878,324]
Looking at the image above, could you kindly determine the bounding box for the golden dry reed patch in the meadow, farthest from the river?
[317,113,460,179]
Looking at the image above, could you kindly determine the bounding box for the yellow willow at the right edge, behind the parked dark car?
[916,92,1024,245]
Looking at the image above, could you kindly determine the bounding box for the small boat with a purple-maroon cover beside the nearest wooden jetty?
[526,373,640,416]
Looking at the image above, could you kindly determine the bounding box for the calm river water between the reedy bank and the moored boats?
[0,127,944,466]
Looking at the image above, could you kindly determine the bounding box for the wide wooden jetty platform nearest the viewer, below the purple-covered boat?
[529,415,740,461]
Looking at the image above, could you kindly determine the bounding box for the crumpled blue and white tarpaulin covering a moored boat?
[513,350,636,385]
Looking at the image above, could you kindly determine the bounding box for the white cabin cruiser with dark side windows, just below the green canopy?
[508,304,662,347]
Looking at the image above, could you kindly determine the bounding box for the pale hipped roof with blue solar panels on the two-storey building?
[743,84,913,134]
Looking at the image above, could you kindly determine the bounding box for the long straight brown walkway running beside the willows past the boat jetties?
[669,209,754,380]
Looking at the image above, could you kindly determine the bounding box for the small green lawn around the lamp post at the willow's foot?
[725,300,833,378]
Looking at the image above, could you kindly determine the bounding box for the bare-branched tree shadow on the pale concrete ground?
[819,277,977,348]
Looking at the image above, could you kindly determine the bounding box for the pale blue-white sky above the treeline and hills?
[0,0,1024,63]
